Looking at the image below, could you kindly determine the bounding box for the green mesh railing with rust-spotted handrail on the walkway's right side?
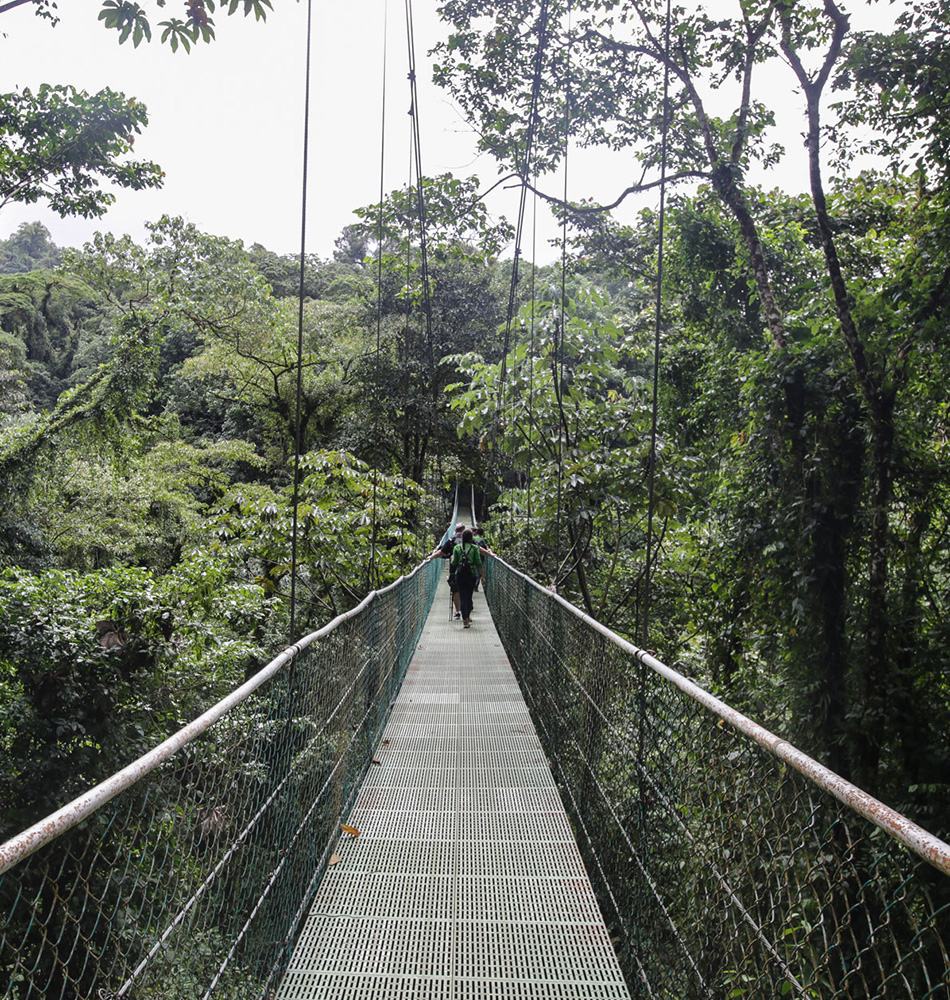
[487,559,950,1000]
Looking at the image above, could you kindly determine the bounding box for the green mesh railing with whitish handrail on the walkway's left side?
[0,562,440,1000]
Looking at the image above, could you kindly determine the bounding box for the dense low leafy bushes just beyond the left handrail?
[0,552,274,836]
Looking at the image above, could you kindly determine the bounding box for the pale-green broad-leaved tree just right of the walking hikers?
[449,289,685,631]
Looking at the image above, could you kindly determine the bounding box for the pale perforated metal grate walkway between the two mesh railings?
[276,572,629,1000]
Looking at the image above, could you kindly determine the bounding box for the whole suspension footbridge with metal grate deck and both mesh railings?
[0,500,950,1000]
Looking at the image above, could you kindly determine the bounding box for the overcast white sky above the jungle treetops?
[0,0,887,260]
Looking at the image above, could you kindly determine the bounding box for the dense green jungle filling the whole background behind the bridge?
[0,0,950,852]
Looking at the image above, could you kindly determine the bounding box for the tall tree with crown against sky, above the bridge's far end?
[327,174,511,482]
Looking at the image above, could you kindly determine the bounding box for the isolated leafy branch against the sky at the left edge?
[0,83,164,218]
